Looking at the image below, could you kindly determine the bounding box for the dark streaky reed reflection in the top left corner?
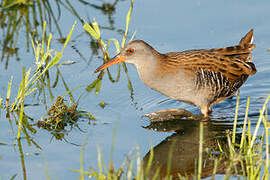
[0,0,62,68]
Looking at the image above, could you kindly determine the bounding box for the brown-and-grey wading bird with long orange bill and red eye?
[95,29,257,118]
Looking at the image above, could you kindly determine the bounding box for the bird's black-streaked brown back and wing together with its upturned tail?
[159,29,256,82]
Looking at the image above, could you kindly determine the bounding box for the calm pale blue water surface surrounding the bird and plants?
[0,0,270,179]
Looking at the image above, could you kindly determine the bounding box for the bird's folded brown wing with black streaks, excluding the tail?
[161,50,256,82]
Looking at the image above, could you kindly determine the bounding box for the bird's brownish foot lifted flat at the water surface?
[143,109,204,122]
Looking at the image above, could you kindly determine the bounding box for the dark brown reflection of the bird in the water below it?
[143,119,243,179]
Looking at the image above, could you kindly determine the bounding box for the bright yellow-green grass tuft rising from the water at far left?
[2,20,75,144]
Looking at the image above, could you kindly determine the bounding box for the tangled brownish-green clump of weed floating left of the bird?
[37,96,80,132]
